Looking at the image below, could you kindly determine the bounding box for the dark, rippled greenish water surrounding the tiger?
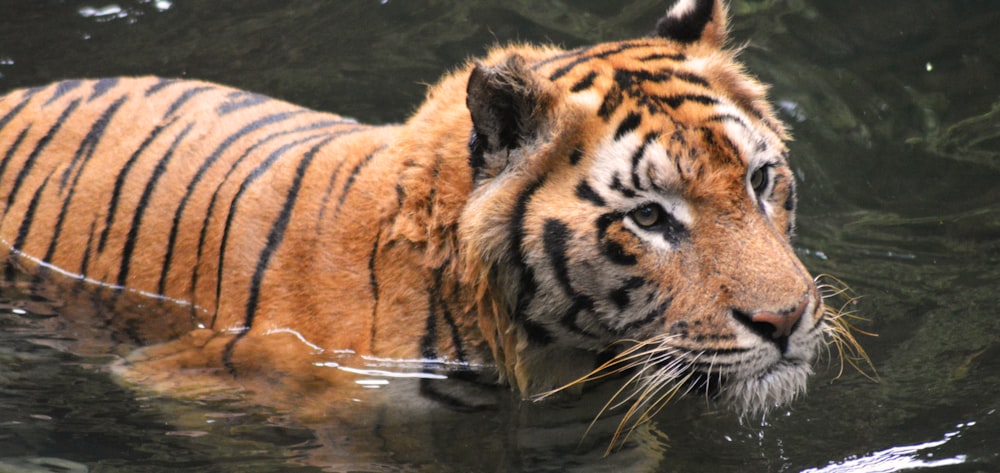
[0,0,1000,472]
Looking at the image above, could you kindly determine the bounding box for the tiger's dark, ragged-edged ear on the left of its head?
[465,54,555,177]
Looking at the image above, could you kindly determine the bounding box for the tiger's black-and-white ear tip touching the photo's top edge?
[656,0,727,48]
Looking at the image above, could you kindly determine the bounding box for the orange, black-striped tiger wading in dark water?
[0,0,855,424]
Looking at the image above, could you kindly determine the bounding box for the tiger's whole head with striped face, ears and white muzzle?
[460,0,844,413]
